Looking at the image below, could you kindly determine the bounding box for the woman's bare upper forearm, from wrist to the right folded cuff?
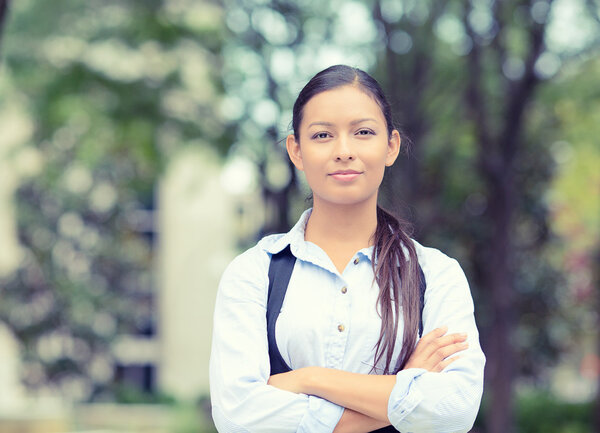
[301,367,396,420]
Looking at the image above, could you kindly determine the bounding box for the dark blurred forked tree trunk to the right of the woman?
[465,0,552,433]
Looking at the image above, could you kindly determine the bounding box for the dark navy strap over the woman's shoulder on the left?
[267,245,296,375]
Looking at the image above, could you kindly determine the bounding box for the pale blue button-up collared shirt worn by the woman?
[210,209,485,433]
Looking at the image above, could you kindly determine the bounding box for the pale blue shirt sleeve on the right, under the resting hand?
[388,252,485,433]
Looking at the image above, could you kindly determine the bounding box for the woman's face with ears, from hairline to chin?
[286,85,400,205]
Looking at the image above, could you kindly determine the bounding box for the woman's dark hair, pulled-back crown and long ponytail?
[292,65,420,374]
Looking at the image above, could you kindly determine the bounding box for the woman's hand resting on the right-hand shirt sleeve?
[404,326,469,373]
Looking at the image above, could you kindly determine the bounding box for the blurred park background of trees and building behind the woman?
[0,0,600,433]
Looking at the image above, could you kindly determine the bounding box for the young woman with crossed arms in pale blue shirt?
[210,65,485,433]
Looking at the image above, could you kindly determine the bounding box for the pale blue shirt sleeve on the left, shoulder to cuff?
[210,246,344,433]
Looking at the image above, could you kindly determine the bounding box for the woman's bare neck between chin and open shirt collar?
[304,198,377,251]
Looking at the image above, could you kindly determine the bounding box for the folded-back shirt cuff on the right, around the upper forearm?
[388,368,427,427]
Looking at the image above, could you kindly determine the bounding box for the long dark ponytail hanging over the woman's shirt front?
[372,206,421,374]
